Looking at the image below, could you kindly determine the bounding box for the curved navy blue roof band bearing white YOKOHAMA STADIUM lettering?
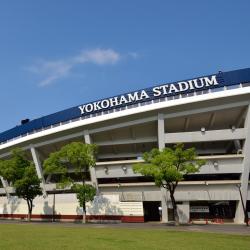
[0,68,250,144]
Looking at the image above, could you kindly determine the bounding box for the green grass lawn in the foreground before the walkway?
[0,224,250,250]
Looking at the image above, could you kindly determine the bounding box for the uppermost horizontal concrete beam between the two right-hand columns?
[165,128,246,143]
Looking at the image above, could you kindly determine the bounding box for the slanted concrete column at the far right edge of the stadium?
[235,106,250,223]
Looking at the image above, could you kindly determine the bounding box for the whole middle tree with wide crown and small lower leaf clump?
[44,142,97,223]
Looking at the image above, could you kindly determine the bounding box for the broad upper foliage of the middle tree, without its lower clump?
[44,142,97,187]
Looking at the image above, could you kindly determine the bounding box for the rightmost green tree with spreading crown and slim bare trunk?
[133,144,205,224]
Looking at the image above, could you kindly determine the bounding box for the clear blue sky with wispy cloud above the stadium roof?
[0,0,250,131]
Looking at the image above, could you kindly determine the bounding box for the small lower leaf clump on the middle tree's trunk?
[72,184,96,209]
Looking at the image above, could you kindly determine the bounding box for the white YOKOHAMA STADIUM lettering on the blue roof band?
[78,75,219,115]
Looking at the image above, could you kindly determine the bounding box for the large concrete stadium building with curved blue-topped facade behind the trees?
[0,68,250,223]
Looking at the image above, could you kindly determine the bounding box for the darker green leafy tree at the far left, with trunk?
[0,149,42,221]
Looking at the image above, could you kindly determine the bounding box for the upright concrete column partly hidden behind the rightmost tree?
[158,114,168,222]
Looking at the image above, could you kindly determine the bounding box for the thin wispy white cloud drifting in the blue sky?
[26,48,121,87]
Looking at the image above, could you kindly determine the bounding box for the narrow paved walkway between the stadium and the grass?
[0,220,250,236]
